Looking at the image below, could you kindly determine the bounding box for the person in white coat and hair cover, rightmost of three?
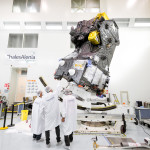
[62,89,77,150]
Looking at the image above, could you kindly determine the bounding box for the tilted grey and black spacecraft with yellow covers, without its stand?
[55,13,119,104]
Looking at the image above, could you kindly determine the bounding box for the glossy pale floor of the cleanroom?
[0,114,150,150]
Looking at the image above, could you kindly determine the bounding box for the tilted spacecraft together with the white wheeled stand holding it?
[54,13,134,133]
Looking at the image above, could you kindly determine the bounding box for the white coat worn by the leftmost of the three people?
[31,97,44,135]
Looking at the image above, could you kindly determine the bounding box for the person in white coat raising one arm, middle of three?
[41,83,62,148]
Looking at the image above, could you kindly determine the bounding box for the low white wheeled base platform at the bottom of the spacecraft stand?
[77,113,135,134]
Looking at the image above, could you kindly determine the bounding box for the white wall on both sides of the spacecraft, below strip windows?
[0,28,150,105]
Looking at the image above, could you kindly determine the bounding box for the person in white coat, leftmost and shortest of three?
[31,91,44,142]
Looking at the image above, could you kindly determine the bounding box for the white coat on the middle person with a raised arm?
[41,86,61,131]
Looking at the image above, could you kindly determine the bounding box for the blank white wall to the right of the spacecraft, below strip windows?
[109,28,150,105]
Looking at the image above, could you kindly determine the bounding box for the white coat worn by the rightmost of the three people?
[62,95,77,135]
